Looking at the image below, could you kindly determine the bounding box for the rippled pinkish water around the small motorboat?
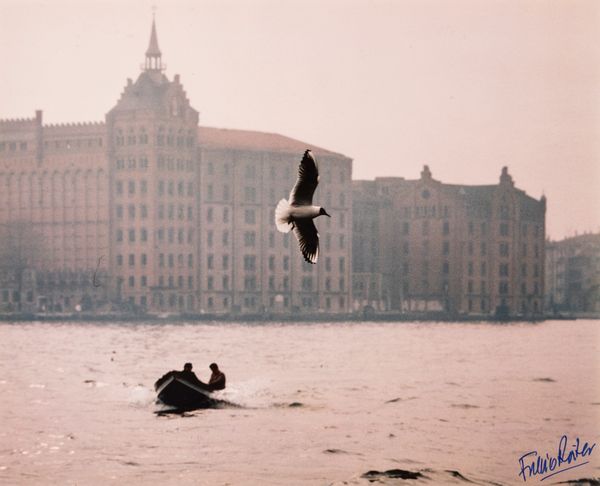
[0,321,600,485]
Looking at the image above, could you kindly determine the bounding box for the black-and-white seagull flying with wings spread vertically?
[275,150,331,263]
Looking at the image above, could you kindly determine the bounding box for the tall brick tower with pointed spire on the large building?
[106,20,198,312]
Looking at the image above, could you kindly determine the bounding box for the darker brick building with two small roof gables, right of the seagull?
[353,166,546,316]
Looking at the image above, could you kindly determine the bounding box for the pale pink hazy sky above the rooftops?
[0,0,600,239]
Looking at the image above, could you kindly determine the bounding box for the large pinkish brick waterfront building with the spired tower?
[0,23,352,313]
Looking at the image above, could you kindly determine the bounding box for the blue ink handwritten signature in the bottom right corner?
[519,435,596,481]
